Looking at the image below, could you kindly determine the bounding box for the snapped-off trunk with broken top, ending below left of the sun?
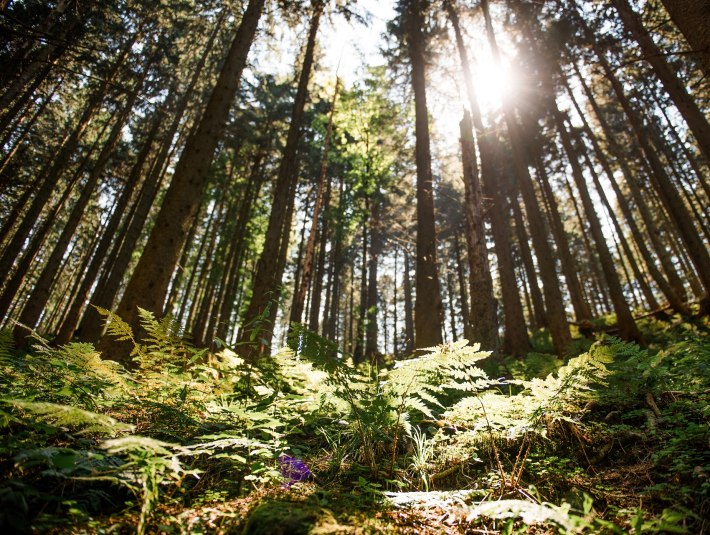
[458,111,498,353]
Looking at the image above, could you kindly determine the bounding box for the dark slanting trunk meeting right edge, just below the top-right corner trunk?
[612,0,710,163]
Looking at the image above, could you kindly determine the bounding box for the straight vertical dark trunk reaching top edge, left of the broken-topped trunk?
[405,0,444,347]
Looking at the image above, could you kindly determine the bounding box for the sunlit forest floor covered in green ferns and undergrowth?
[0,315,710,534]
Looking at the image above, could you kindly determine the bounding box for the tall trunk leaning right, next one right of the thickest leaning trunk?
[240,0,325,359]
